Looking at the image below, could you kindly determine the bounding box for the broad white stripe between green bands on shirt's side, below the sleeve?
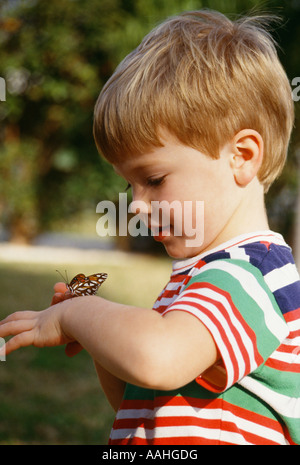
[239,376,300,419]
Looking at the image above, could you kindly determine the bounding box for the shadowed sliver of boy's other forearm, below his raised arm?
[94,360,126,411]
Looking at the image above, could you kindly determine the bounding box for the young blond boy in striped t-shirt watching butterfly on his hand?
[0,10,300,445]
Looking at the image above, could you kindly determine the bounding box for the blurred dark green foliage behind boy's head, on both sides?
[0,0,300,245]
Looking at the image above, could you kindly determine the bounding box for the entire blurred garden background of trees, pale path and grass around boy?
[0,0,300,444]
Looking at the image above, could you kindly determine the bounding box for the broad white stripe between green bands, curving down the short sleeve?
[202,260,289,342]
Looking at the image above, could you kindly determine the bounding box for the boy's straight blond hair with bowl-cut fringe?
[94,10,294,190]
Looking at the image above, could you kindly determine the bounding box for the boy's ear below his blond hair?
[230,129,264,187]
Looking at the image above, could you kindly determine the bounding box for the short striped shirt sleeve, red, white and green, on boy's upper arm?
[163,259,289,392]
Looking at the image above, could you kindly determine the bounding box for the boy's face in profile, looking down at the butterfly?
[114,132,245,258]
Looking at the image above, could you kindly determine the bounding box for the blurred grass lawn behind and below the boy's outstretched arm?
[0,252,170,445]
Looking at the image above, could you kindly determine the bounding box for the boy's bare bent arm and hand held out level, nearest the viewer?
[0,296,218,390]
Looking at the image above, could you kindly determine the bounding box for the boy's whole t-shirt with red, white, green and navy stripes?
[109,231,300,445]
